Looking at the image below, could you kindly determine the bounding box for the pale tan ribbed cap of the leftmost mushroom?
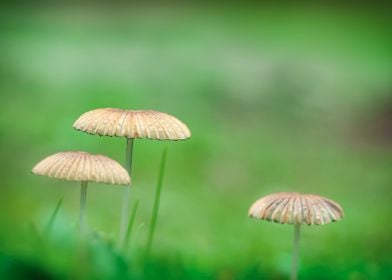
[32,151,131,185]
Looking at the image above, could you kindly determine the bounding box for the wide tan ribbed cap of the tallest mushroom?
[73,108,191,140]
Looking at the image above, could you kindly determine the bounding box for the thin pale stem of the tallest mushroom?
[119,138,133,248]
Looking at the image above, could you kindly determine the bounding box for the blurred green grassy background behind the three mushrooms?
[0,3,392,279]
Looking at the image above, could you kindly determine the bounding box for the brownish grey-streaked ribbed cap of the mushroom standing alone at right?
[249,192,344,225]
